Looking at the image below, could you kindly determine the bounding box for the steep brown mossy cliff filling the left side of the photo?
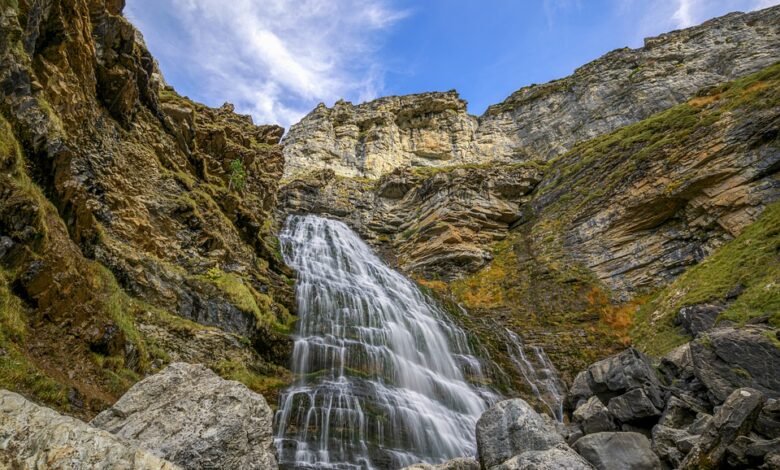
[0,0,293,416]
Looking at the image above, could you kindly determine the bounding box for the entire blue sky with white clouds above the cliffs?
[125,0,780,127]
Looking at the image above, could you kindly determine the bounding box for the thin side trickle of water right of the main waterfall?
[506,330,565,421]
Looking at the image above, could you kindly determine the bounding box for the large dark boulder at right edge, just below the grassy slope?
[691,325,780,405]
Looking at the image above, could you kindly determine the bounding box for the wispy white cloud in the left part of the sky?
[127,0,407,126]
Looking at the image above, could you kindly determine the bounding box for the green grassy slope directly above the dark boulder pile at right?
[631,202,780,355]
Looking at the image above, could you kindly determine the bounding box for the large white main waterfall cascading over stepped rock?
[275,215,495,469]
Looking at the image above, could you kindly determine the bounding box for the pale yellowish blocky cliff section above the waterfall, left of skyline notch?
[284,91,481,179]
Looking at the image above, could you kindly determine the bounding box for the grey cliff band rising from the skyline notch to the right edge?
[482,7,780,161]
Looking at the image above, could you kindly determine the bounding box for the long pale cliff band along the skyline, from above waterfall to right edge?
[284,8,780,179]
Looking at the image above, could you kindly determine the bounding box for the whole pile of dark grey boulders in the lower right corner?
[567,326,780,469]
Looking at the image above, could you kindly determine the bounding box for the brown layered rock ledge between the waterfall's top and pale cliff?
[279,165,542,279]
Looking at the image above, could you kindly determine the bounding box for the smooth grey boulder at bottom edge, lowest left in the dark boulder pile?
[574,432,661,470]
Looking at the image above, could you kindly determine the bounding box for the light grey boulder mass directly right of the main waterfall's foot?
[477,398,591,470]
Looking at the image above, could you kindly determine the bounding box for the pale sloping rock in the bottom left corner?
[0,390,179,470]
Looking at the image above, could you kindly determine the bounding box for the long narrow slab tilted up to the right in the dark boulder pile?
[680,388,764,469]
